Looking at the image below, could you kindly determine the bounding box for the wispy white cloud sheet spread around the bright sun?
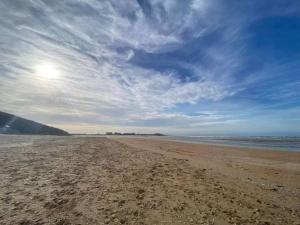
[0,0,300,134]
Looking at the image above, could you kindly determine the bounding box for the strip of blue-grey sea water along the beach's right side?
[159,136,300,152]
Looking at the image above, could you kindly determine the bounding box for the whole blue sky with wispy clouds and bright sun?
[0,0,300,135]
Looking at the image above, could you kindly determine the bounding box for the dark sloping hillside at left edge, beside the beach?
[0,111,70,136]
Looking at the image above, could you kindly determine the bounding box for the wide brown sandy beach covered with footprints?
[0,136,300,225]
